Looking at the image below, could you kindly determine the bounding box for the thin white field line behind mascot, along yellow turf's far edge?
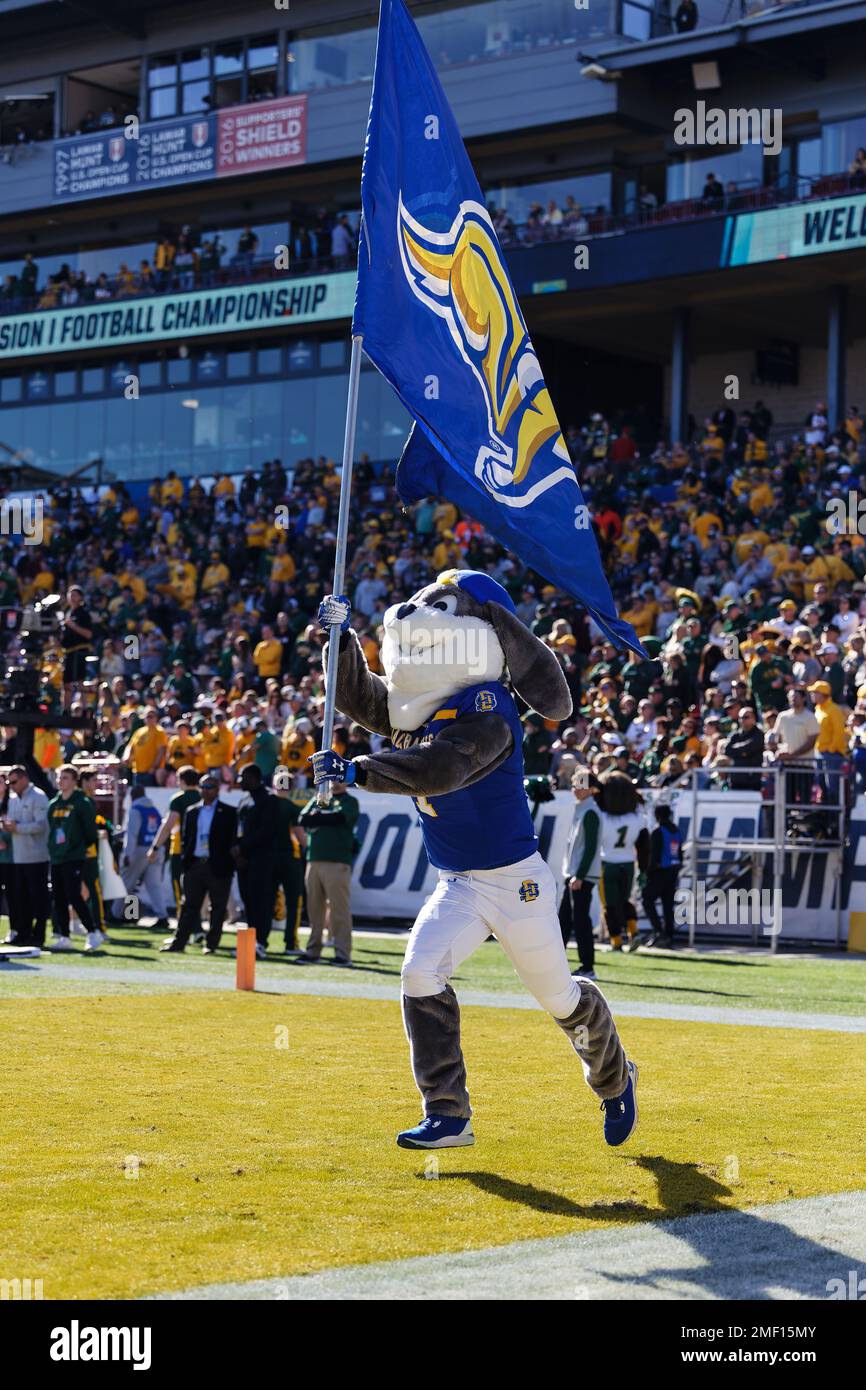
[6,962,866,1033]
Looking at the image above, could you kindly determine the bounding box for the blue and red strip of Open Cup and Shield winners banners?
[51,96,307,203]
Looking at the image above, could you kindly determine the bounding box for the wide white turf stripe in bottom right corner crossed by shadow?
[149,1193,866,1295]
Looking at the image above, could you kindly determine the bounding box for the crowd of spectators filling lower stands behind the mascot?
[0,386,866,834]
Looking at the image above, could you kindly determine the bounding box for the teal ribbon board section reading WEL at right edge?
[721,193,866,265]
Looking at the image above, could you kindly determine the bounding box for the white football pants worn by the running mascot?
[402,853,581,1019]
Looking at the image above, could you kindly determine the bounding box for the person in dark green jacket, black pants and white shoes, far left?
[49,763,103,951]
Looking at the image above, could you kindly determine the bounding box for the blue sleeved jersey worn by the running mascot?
[403,681,538,873]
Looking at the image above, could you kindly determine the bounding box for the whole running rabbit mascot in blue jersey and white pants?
[313,570,638,1148]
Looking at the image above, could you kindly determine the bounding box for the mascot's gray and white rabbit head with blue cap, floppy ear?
[381,570,571,730]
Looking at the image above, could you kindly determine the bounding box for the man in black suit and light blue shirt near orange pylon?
[160,773,238,955]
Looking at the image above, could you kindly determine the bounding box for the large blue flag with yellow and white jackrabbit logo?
[353,0,644,655]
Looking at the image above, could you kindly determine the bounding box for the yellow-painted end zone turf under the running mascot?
[0,994,866,1298]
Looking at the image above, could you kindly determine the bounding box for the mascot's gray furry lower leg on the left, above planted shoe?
[403,984,469,1119]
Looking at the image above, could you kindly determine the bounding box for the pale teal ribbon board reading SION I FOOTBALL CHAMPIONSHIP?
[0,271,356,361]
